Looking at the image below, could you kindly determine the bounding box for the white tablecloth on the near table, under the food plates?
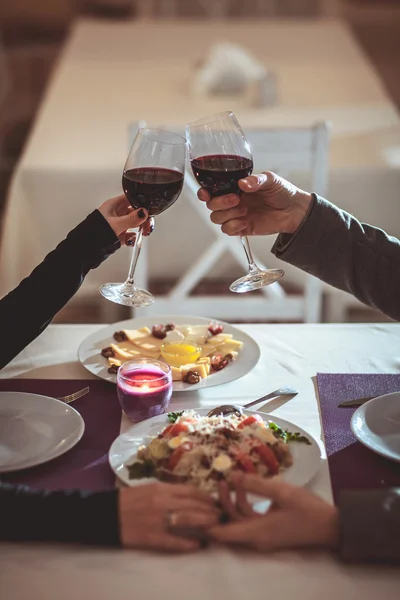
[0,324,400,600]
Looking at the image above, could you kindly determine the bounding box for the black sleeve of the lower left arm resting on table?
[0,483,120,546]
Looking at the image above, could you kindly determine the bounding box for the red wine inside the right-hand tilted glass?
[191,154,253,196]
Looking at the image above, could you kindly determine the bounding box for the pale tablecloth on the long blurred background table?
[0,19,400,304]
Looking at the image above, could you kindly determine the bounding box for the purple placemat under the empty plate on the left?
[0,379,121,490]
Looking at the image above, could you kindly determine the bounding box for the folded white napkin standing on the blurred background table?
[193,42,266,94]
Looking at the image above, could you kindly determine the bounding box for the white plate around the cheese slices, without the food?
[78,315,261,392]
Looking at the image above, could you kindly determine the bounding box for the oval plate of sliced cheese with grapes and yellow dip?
[78,315,260,391]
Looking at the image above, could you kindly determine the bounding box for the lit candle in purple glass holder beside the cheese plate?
[117,358,172,421]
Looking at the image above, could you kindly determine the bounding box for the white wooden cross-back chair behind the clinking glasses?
[130,123,329,323]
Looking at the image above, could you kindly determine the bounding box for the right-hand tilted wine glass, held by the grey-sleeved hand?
[186,111,284,293]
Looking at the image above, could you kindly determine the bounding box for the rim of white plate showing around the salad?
[108,408,321,496]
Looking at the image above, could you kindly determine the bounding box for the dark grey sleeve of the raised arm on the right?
[272,194,400,321]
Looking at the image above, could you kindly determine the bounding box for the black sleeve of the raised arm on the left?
[0,210,120,369]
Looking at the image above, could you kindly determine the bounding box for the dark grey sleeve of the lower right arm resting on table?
[339,488,400,563]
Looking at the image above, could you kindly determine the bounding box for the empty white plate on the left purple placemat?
[0,392,85,473]
